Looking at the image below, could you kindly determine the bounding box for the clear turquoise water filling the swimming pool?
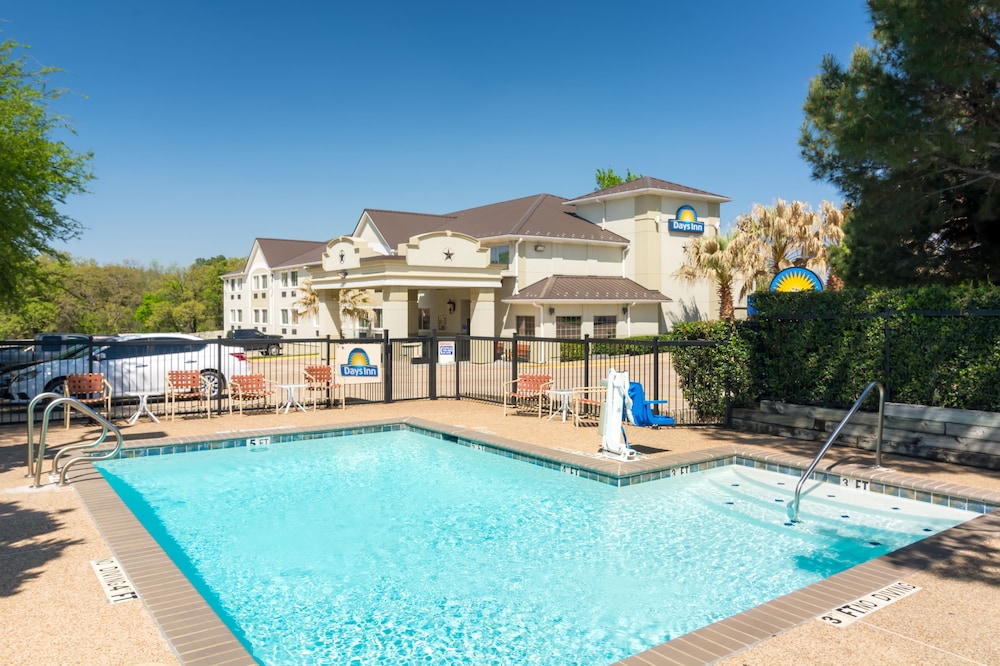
[98,431,973,666]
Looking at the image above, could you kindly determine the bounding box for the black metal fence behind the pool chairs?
[0,334,718,424]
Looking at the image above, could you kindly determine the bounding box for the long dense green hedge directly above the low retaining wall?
[737,286,1000,412]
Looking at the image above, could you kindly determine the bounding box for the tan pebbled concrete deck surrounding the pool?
[0,400,1000,666]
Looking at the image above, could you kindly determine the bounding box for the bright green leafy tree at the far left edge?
[0,40,93,303]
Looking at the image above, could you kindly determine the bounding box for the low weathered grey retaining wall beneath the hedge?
[733,401,1000,469]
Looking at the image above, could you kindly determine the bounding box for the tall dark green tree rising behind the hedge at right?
[800,0,1000,286]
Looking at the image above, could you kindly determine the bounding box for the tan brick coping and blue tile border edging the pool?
[72,417,1000,666]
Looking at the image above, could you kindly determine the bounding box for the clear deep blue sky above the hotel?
[0,0,871,265]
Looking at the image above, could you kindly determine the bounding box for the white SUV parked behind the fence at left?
[10,333,250,403]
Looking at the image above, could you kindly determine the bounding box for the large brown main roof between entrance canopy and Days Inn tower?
[365,194,628,250]
